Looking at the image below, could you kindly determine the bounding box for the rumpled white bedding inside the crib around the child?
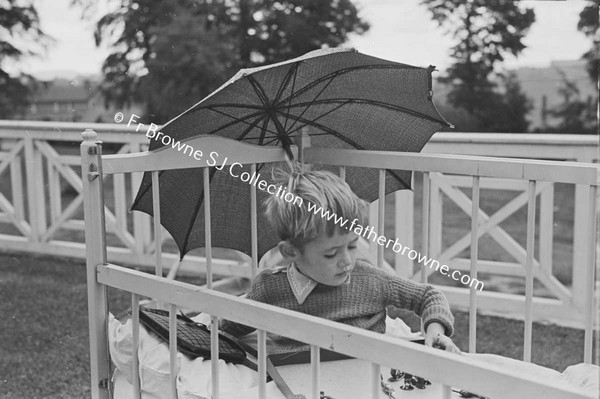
[108,314,600,399]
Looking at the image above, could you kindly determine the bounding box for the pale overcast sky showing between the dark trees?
[7,0,591,79]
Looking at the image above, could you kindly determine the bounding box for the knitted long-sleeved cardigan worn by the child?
[220,260,454,353]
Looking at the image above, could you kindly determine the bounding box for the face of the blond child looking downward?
[293,231,358,286]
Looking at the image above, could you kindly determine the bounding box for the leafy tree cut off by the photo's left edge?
[0,0,48,119]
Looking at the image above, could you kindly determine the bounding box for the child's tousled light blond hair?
[265,162,367,250]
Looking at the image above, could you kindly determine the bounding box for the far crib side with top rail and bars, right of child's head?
[304,148,600,363]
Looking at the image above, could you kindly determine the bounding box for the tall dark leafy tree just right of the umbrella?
[421,0,535,131]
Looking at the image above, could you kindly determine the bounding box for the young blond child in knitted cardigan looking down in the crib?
[220,164,460,353]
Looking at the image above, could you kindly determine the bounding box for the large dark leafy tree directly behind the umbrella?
[87,0,368,123]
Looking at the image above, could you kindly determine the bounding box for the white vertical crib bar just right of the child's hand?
[469,176,479,353]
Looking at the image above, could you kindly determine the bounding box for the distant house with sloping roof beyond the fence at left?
[21,79,142,123]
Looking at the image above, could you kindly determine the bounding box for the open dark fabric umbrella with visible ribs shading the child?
[132,48,450,257]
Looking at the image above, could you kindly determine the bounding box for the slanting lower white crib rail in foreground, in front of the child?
[96,264,592,399]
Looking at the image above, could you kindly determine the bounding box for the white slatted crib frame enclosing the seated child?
[81,129,598,399]
